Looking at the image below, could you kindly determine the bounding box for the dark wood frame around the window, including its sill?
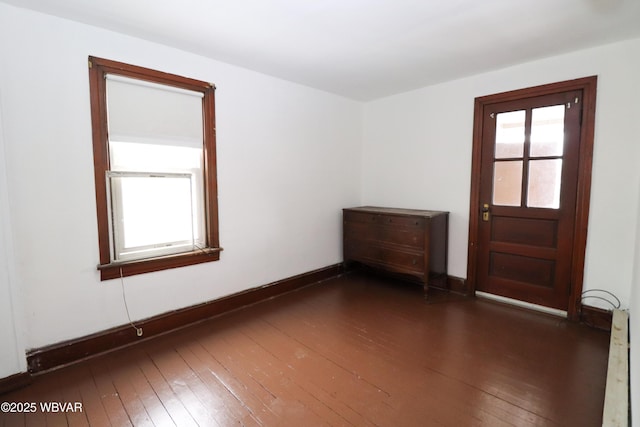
[89,56,222,280]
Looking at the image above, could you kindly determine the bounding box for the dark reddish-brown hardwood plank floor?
[0,273,609,427]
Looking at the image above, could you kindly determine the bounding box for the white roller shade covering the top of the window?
[106,75,203,148]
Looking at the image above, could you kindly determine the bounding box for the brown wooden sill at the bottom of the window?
[98,248,222,280]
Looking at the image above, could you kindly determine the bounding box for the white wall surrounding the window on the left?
[0,4,362,364]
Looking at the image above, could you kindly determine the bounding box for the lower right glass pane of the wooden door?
[527,159,562,209]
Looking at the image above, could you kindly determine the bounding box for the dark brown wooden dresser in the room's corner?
[343,206,449,297]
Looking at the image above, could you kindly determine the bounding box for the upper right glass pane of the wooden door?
[531,104,564,157]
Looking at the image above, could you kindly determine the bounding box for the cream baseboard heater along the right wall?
[602,309,630,427]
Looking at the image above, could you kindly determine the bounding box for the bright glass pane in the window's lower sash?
[112,177,196,251]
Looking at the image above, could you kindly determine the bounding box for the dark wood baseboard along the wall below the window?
[27,263,344,373]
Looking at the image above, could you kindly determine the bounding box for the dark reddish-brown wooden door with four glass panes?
[470,78,590,311]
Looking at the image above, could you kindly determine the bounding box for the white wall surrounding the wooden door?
[363,39,640,308]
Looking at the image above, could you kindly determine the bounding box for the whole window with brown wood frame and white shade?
[89,57,221,280]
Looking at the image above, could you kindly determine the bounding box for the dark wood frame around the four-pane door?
[467,76,598,320]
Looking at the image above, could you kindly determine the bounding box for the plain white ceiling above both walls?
[0,0,640,101]
